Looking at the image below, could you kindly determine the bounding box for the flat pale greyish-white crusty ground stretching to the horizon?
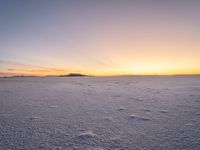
[0,76,200,150]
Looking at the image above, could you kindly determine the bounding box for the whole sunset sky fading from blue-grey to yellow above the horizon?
[0,0,200,76]
